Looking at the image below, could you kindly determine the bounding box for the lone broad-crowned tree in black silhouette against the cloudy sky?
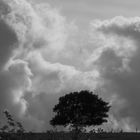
[50,90,110,131]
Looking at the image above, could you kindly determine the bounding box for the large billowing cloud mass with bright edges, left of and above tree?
[0,0,99,131]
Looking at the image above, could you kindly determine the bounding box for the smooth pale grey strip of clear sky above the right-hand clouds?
[36,0,140,26]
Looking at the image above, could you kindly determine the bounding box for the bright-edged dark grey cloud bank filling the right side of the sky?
[91,17,140,131]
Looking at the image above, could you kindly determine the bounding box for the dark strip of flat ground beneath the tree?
[0,132,140,140]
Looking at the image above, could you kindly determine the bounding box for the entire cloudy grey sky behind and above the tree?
[0,0,140,131]
